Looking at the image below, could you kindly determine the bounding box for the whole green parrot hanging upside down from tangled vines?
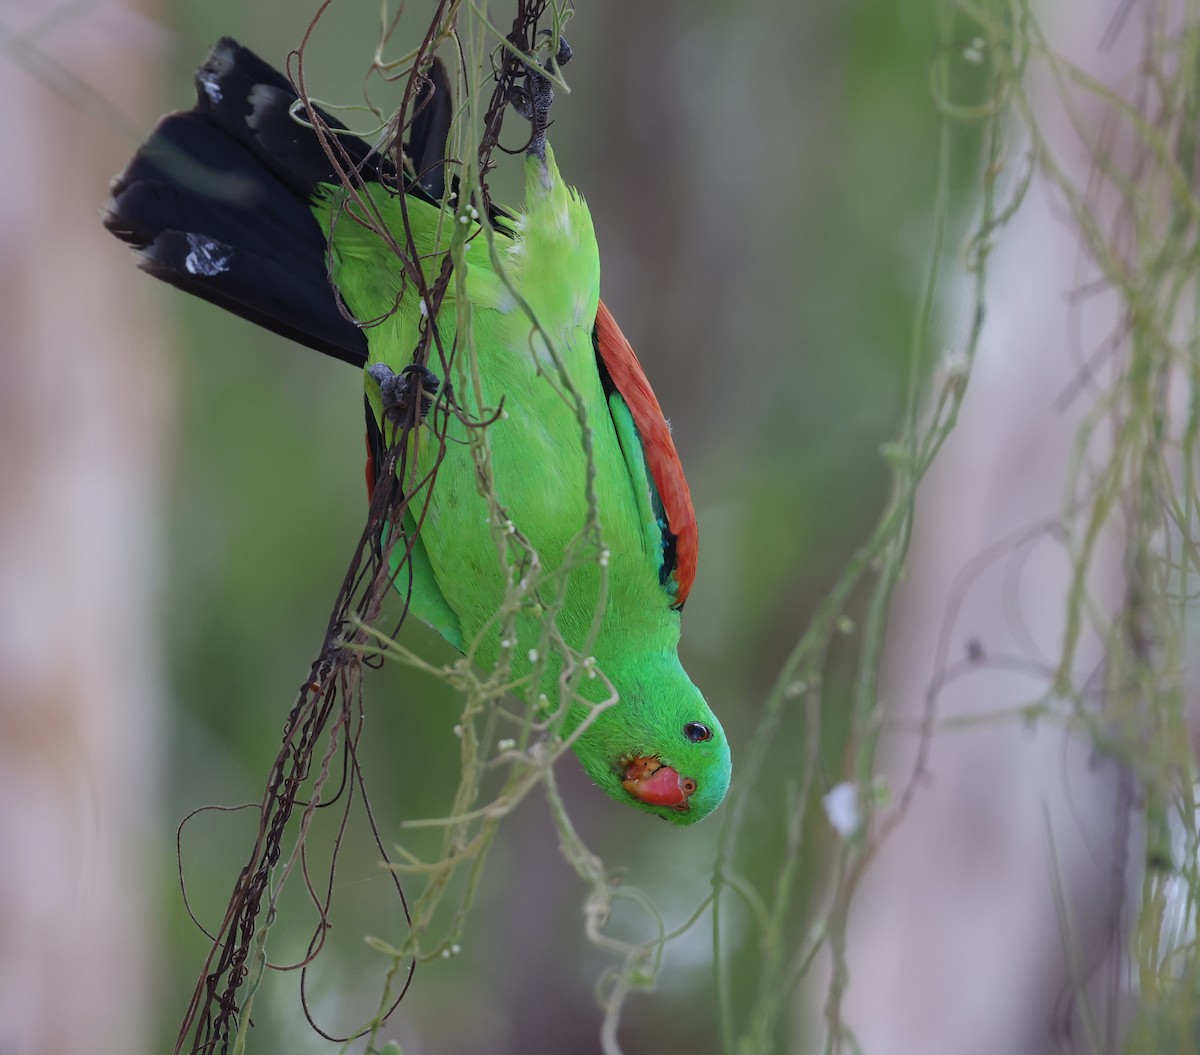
[104,38,731,825]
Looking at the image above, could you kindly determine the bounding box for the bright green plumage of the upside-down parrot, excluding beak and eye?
[316,151,730,823]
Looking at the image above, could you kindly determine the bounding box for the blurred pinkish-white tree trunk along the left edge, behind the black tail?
[0,4,166,1055]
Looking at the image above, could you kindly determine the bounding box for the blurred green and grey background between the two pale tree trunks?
[79,0,972,1055]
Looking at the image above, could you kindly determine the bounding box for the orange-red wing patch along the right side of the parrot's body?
[595,300,700,609]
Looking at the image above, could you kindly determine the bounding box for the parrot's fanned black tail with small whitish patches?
[104,37,451,366]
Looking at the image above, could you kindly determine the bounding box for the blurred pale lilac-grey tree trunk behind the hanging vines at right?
[825,0,1154,1055]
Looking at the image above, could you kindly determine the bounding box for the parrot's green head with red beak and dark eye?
[575,653,731,825]
